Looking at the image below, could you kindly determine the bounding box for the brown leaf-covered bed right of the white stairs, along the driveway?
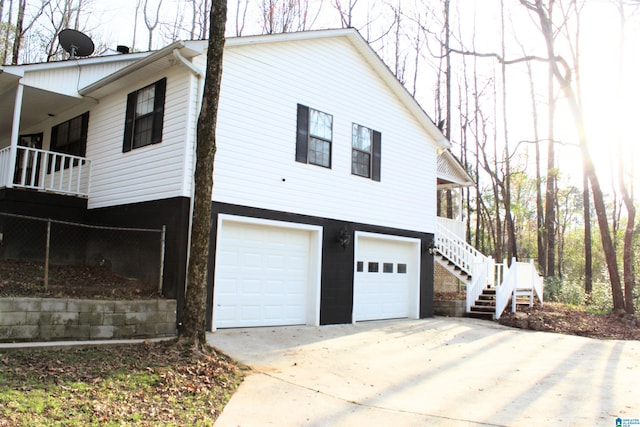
[499,303,640,340]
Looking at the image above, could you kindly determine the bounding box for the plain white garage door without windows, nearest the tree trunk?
[213,222,311,328]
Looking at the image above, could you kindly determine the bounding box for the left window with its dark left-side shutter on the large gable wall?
[296,104,333,168]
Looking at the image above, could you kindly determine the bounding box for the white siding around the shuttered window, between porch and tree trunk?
[87,66,192,209]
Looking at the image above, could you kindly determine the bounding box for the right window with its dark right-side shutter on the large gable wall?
[351,123,382,181]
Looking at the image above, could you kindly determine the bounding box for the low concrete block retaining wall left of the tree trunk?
[0,298,176,342]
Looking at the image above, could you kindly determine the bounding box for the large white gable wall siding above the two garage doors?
[213,39,436,232]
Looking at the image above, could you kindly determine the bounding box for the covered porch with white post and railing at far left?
[0,65,92,198]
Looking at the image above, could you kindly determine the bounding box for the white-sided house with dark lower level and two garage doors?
[0,29,448,329]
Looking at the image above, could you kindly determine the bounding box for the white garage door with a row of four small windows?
[353,237,419,321]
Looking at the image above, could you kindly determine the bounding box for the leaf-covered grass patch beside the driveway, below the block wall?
[0,342,242,426]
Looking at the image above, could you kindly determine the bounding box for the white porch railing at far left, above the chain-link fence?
[0,147,91,197]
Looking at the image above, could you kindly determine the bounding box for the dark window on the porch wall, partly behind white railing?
[48,111,89,171]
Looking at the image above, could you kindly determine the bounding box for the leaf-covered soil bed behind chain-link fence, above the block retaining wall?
[0,260,162,300]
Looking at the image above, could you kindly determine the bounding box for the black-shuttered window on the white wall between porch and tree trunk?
[122,78,167,152]
